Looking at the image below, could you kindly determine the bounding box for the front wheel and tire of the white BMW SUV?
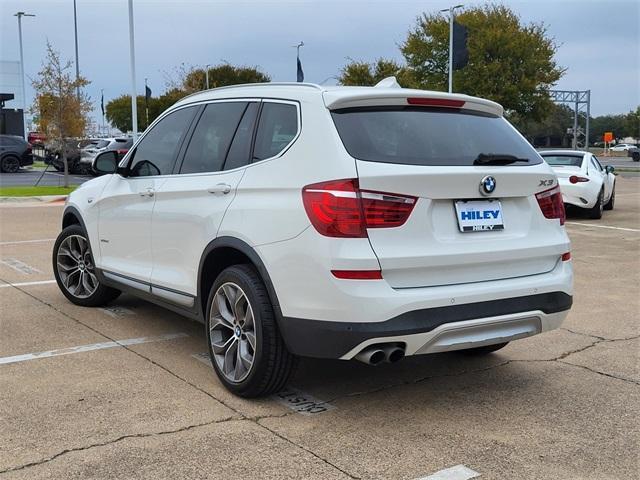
[52,225,120,307]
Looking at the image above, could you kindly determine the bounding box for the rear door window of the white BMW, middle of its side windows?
[180,102,247,173]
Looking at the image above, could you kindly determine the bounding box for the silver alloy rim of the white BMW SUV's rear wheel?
[209,282,256,383]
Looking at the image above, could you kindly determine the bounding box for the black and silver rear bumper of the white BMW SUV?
[280,292,573,360]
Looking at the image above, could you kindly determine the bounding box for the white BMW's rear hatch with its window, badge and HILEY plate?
[330,95,568,288]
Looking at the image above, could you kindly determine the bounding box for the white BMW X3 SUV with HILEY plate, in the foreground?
[53,79,573,397]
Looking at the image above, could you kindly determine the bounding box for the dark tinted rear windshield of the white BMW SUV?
[331,107,542,166]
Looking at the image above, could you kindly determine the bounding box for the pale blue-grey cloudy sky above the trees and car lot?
[0,0,640,127]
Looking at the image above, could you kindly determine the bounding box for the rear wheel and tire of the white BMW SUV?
[206,265,297,398]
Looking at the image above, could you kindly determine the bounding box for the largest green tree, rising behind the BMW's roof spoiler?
[341,5,565,120]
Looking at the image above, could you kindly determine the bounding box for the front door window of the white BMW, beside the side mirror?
[130,107,197,177]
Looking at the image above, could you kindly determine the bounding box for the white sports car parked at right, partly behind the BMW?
[540,150,616,218]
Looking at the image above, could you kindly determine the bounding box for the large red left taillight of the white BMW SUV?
[302,179,417,238]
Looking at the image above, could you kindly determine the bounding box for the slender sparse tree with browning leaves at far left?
[31,41,92,187]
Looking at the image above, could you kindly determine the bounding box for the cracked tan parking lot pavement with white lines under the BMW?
[0,177,640,480]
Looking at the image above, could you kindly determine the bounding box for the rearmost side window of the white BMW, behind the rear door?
[253,102,298,160]
